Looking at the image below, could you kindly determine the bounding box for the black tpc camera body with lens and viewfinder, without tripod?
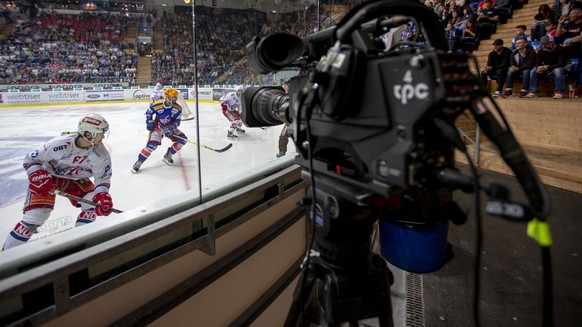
[242,2,472,201]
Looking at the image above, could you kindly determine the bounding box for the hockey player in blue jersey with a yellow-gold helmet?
[131,88,188,174]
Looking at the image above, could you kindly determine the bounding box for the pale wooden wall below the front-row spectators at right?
[455,97,582,193]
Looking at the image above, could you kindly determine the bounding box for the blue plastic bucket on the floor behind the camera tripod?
[379,219,449,273]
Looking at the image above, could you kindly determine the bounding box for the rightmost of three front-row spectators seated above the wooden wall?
[525,35,566,99]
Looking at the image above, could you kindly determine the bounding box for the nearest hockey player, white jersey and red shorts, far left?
[2,114,113,250]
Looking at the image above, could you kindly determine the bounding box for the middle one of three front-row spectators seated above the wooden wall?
[503,38,537,98]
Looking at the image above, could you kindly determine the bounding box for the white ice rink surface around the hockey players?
[0,102,293,246]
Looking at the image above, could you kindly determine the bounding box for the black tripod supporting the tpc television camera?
[285,182,393,326]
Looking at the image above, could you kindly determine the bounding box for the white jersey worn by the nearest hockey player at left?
[23,134,112,193]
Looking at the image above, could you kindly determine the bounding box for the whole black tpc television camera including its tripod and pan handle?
[242,0,550,326]
